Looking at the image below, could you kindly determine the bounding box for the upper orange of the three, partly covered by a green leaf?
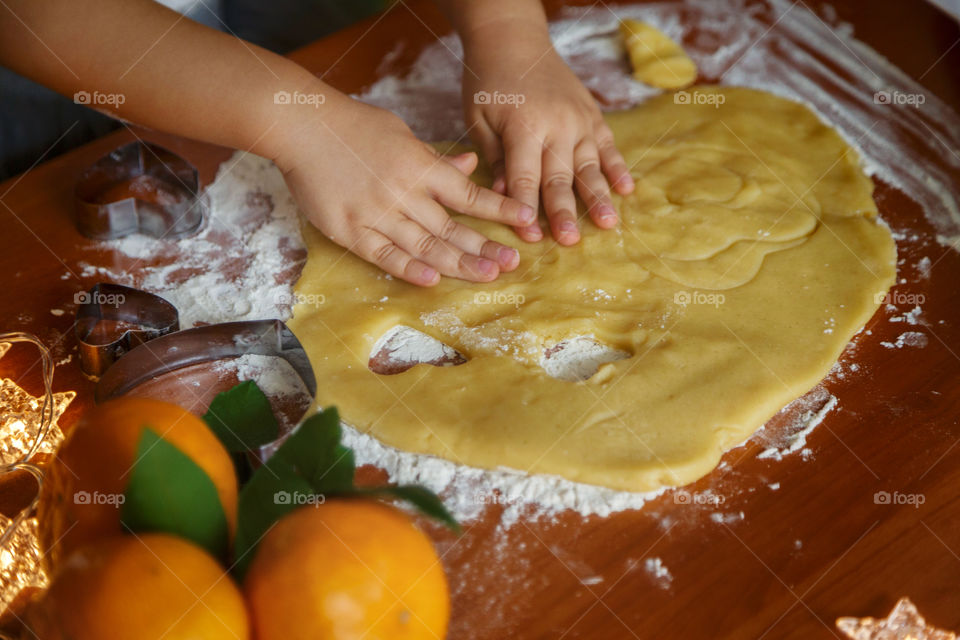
[37,397,237,570]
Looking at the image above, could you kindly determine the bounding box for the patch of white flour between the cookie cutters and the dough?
[86,152,305,328]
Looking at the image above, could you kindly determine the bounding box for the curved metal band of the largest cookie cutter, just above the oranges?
[95,320,317,403]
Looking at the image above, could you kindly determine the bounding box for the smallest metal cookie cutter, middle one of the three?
[74,282,180,376]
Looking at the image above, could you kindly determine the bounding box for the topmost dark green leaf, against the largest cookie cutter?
[203,380,280,451]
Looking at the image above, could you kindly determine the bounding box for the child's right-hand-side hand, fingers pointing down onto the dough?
[463,26,634,245]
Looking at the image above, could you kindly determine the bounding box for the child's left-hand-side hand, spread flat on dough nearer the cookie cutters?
[275,94,536,286]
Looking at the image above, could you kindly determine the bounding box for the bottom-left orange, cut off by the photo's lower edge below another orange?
[25,533,250,640]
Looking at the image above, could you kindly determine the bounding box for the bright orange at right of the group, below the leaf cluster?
[243,499,450,640]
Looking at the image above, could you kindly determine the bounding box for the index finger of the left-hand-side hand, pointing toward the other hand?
[431,163,536,226]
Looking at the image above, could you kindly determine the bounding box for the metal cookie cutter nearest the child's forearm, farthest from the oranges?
[75,141,206,240]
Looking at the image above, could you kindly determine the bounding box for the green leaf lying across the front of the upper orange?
[120,428,229,558]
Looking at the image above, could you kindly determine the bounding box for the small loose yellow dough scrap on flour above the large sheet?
[620,19,697,89]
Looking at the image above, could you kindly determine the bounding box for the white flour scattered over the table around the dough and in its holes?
[92,0,960,524]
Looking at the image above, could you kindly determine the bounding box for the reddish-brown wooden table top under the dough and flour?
[0,0,960,640]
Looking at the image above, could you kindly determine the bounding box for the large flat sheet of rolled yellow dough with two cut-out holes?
[290,87,896,491]
